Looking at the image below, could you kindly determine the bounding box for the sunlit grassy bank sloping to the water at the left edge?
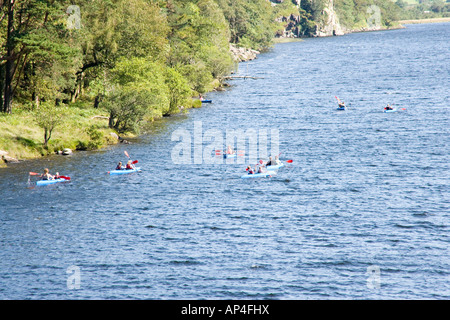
[0,104,118,163]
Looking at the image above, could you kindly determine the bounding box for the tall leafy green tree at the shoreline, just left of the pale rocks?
[168,0,233,92]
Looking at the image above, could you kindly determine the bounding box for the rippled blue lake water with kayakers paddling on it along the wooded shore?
[0,23,450,300]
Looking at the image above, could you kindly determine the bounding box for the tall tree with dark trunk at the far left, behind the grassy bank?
[0,0,78,113]
